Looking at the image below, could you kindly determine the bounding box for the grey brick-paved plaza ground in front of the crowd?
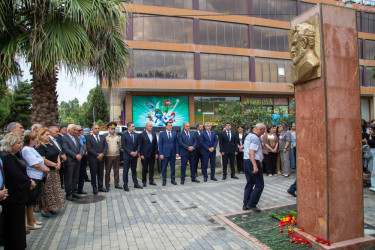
[27,174,375,249]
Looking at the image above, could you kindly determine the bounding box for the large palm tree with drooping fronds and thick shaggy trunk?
[0,0,130,125]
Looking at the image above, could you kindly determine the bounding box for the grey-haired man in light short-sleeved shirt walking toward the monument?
[243,123,266,212]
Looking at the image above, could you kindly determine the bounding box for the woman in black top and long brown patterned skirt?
[37,129,64,218]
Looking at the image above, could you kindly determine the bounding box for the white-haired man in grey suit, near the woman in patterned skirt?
[61,124,83,201]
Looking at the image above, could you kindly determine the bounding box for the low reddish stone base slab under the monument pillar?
[293,228,375,250]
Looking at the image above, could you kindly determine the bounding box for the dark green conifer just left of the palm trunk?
[7,81,32,128]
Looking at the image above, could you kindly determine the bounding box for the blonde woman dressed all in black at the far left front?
[0,133,35,249]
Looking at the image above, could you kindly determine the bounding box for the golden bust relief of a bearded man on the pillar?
[288,16,321,84]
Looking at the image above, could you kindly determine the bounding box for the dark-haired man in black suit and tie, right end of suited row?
[219,122,238,180]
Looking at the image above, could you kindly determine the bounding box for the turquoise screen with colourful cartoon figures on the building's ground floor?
[133,96,189,127]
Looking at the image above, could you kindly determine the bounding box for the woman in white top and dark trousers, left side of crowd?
[22,132,49,230]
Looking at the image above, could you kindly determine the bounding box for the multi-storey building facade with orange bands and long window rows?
[103,0,375,127]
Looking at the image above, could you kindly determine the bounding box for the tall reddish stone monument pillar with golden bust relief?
[289,4,373,247]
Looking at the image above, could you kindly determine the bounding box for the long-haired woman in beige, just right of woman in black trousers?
[279,123,292,177]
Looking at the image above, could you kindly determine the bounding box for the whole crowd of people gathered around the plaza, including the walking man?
[0,122,296,249]
